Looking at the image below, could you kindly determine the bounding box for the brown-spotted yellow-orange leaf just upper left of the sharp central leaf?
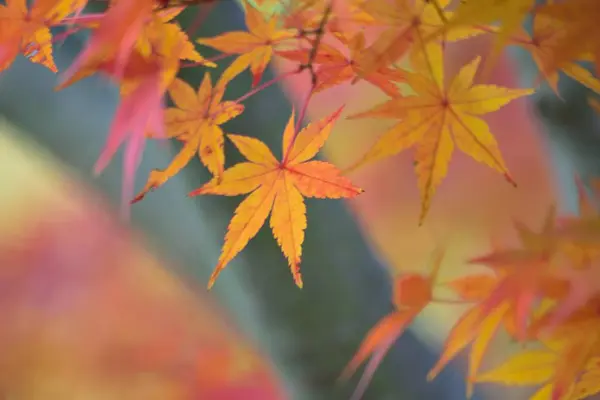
[132,72,244,202]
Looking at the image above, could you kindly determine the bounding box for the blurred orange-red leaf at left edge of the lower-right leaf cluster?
[427,207,567,398]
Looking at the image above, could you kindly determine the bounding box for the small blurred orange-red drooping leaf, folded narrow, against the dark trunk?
[341,250,443,400]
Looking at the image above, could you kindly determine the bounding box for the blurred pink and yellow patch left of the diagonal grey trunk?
[0,130,286,400]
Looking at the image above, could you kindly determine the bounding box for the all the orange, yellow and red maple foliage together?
[5,0,600,400]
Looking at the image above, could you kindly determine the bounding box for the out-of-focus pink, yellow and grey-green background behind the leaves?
[0,2,600,400]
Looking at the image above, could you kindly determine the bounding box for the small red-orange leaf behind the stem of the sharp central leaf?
[276,31,404,97]
